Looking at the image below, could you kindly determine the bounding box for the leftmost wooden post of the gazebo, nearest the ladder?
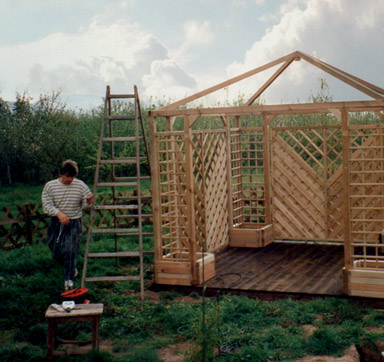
[149,115,162,268]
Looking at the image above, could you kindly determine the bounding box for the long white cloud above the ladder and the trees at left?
[0,17,198,107]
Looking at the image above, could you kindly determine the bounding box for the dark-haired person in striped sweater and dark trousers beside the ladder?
[41,160,93,290]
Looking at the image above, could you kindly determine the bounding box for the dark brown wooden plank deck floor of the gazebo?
[207,243,344,296]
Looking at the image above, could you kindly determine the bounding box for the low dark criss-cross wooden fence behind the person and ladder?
[0,195,152,249]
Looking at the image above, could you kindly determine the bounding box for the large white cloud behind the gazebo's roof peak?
[227,0,384,103]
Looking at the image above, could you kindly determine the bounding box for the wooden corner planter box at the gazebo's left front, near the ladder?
[155,252,215,285]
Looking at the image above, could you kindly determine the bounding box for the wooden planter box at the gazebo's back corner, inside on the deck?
[229,224,274,248]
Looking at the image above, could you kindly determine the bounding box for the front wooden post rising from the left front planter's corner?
[184,116,199,284]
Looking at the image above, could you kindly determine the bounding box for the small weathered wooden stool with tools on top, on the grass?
[45,303,104,360]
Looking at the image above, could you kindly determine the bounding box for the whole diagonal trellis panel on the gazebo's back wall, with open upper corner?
[271,126,344,241]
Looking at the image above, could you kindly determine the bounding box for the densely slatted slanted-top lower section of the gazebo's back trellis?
[271,134,326,239]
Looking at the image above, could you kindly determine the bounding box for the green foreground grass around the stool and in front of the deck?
[0,240,384,362]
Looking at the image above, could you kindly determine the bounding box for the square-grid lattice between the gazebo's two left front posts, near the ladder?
[157,132,189,260]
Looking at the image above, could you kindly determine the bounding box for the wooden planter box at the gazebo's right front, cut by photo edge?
[347,260,384,298]
